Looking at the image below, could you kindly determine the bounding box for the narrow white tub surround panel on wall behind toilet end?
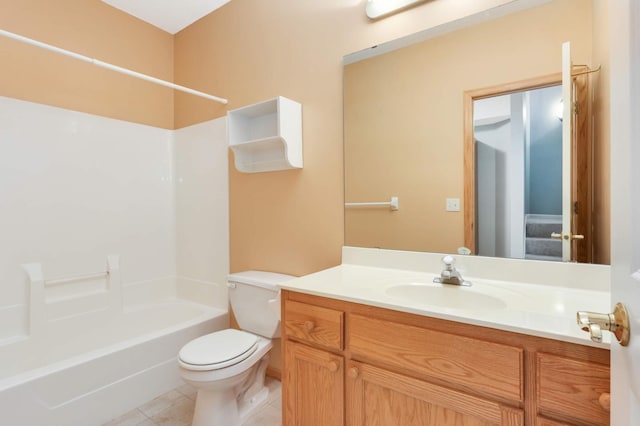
[173,118,229,292]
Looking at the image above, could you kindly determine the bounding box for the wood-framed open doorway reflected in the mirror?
[464,66,598,262]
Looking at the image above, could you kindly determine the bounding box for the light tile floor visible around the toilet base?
[103,377,282,426]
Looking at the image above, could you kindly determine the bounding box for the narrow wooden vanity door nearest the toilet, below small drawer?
[282,341,344,426]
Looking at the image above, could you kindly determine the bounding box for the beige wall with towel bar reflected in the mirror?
[344,0,609,263]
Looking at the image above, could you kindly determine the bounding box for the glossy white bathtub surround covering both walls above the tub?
[0,98,228,341]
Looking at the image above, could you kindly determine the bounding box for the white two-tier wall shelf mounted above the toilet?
[227,96,302,173]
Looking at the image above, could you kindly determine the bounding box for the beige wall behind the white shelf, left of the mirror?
[175,0,516,275]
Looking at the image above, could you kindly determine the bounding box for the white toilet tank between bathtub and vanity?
[227,271,295,339]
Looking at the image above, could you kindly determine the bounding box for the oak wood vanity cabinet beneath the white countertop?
[282,291,609,426]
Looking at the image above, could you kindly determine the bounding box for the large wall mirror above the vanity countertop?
[344,0,610,264]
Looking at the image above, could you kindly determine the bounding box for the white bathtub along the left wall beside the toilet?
[0,272,229,426]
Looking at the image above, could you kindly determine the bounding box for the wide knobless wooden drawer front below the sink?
[348,314,524,402]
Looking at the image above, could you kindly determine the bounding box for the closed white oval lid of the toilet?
[178,329,258,370]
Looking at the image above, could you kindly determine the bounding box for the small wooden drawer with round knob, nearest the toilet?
[284,300,344,350]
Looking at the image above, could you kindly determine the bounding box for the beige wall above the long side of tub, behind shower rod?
[0,0,174,129]
